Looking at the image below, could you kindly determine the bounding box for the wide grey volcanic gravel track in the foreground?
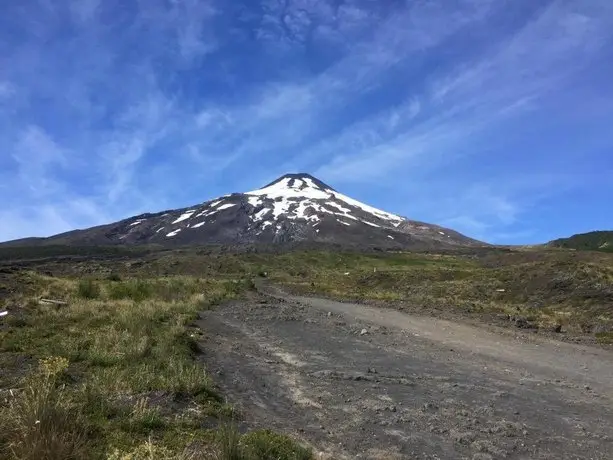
[198,291,613,459]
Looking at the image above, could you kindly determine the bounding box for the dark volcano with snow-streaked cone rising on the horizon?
[3,174,483,252]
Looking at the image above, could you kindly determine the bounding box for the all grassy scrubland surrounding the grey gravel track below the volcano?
[0,247,613,459]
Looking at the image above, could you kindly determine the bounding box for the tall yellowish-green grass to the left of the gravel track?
[0,271,311,460]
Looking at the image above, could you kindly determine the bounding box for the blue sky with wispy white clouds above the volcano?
[0,0,613,244]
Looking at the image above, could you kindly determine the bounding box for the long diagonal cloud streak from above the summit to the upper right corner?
[310,2,613,181]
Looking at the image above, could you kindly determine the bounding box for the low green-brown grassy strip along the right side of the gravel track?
[270,250,613,343]
